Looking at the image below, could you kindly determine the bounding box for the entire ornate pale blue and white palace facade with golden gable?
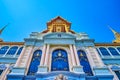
[0,16,120,80]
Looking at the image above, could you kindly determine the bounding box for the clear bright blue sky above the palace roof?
[0,0,120,42]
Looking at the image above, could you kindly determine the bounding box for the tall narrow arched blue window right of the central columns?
[77,50,93,76]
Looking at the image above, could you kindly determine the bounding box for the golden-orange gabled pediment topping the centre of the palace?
[42,16,75,34]
